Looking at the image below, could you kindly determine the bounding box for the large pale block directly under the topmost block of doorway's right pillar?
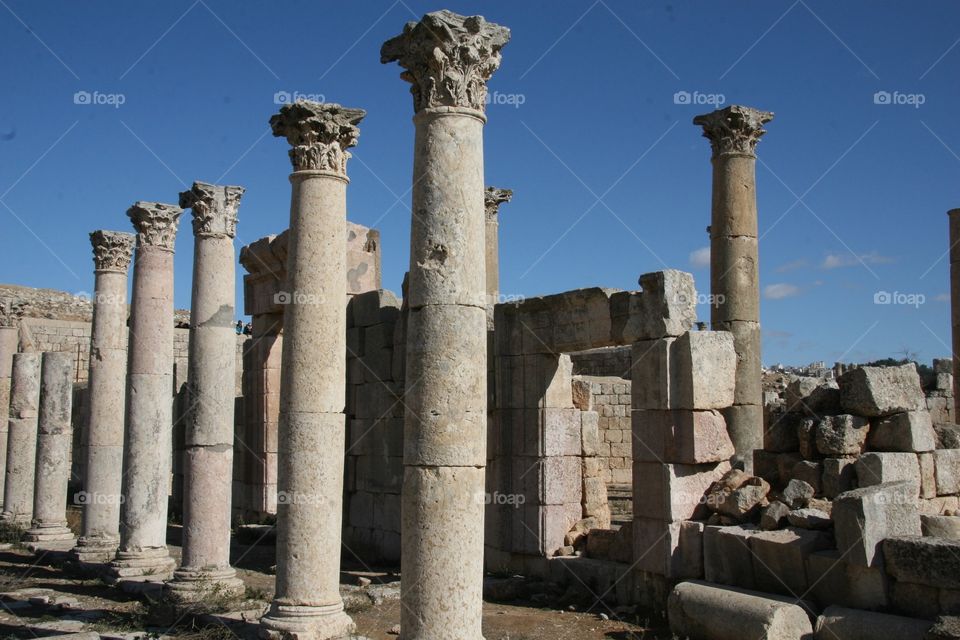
[670,331,737,410]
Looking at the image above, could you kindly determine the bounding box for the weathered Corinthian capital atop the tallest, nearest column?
[380,10,510,112]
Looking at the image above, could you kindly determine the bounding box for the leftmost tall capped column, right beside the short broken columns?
[73,230,135,565]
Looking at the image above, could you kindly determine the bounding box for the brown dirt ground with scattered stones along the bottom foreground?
[0,530,671,640]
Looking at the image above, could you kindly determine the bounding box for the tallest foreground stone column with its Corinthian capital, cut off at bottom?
[380,11,510,640]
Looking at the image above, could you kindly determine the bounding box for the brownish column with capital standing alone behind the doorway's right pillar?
[693,105,773,472]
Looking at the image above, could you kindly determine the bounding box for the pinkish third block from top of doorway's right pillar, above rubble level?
[632,410,734,464]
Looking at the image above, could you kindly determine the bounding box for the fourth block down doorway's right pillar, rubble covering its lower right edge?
[633,462,730,522]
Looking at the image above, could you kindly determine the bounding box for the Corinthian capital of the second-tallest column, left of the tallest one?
[270,100,367,177]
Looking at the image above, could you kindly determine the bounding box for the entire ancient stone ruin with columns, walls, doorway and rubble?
[0,11,960,640]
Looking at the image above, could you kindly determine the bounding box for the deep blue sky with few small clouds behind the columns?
[0,0,960,363]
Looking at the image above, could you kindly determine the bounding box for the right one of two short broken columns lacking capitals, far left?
[23,351,77,551]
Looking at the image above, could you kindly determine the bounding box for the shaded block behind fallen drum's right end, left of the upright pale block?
[750,527,833,597]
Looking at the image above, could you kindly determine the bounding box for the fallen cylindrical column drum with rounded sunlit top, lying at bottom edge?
[667,581,813,640]
